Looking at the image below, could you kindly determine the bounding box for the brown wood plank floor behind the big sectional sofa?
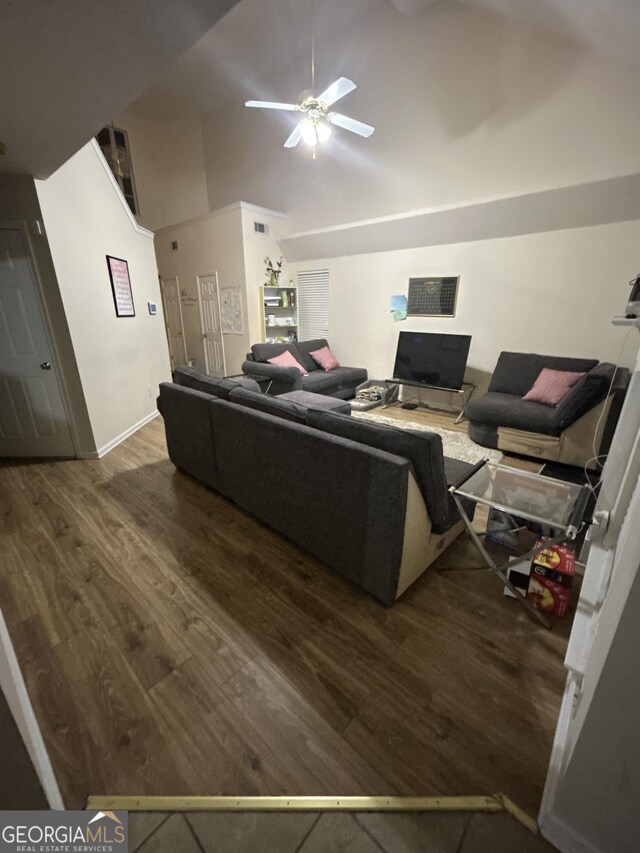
[0,413,569,812]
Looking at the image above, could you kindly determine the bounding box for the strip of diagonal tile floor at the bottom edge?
[129,812,555,853]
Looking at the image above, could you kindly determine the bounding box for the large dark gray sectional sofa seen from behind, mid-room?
[158,374,470,605]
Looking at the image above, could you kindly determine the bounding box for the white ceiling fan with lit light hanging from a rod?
[245,77,375,148]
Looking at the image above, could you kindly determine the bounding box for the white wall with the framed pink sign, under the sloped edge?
[36,143,170,452]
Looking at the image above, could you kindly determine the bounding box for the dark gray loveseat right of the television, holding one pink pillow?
[465,352,629,468]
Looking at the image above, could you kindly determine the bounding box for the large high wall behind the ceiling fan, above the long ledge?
[203,0,640,230]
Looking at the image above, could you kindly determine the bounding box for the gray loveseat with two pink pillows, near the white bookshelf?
[242,338,367,400]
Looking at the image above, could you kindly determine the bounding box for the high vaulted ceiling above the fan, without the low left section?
[131,0,640,119]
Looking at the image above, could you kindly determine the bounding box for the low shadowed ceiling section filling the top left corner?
[0,0,237,177]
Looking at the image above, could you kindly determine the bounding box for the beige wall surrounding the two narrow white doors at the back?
[155,204,251,374]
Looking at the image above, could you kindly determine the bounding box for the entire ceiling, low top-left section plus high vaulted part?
[0,0,640,177]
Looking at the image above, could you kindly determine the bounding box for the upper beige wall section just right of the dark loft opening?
[114,112,209,231]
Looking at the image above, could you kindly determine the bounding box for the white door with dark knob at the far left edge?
[0,223,75,457]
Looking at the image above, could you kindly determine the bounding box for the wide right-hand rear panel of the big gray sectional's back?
[211,400,409,604]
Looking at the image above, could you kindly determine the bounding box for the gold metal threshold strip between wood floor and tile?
[87,795,505,812]
